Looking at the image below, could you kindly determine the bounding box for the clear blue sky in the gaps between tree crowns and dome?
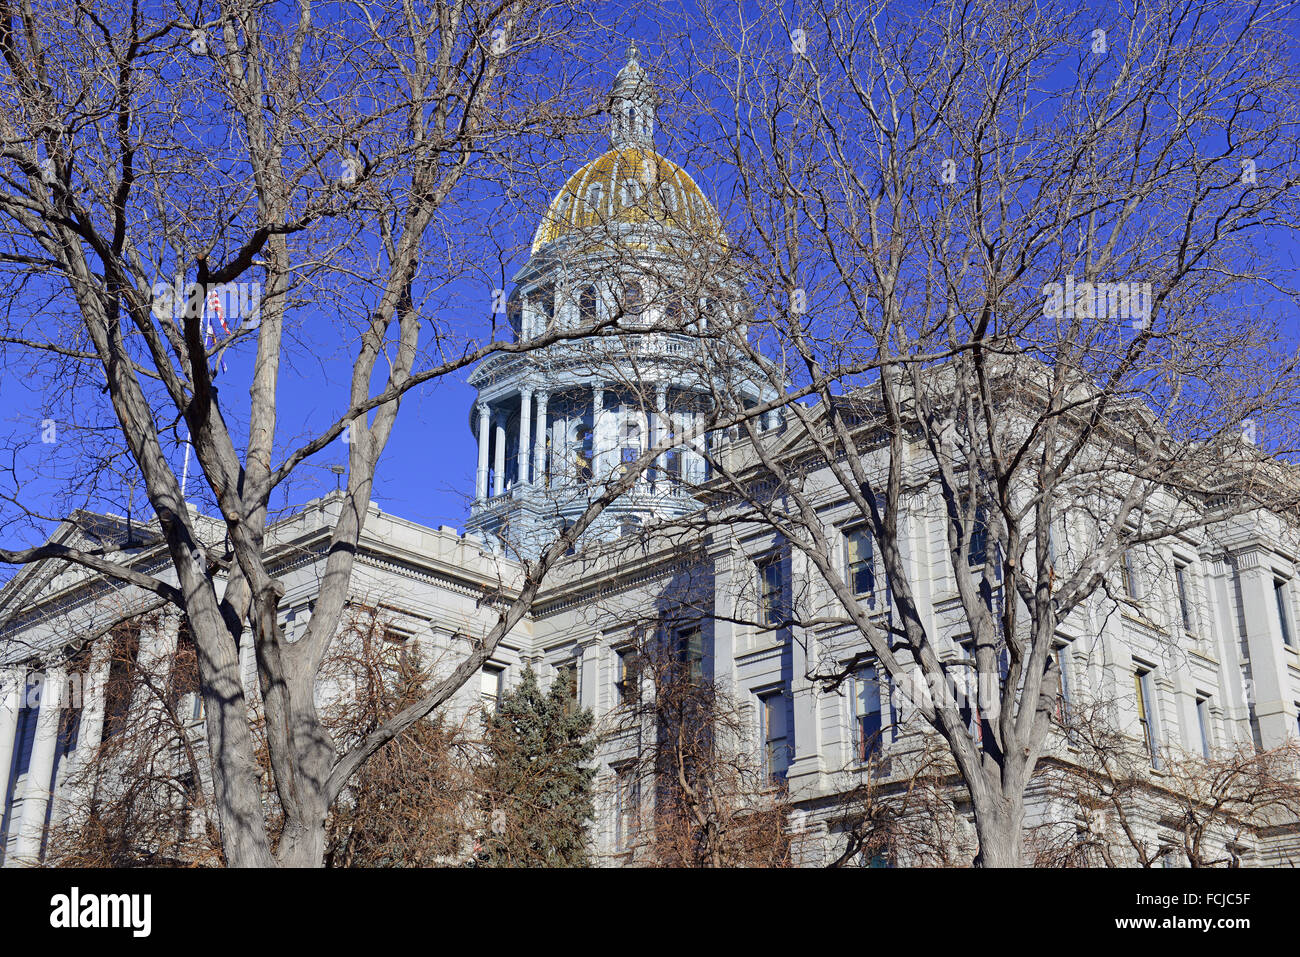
[0,3,1300,561]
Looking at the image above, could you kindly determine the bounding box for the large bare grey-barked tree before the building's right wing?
[647,0,1300,866]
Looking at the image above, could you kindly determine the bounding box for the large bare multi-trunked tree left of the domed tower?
[0,0,696,866]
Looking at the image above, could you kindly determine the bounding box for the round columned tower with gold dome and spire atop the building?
[467,44,777,558]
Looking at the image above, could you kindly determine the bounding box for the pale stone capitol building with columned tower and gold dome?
[0,48,1300,866]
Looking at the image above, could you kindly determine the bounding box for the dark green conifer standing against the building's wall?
[478,668,595,867]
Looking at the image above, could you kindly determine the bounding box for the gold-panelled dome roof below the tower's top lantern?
[533,147,727,252]
